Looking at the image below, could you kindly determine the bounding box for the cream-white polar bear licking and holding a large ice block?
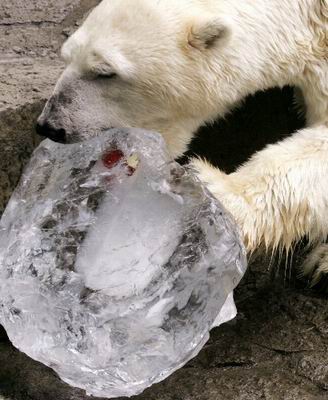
[37,0,328,283]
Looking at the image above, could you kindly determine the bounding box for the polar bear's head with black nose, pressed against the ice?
[38,0,237,156]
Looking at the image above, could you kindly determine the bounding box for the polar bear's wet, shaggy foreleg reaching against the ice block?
[191,125,328,288]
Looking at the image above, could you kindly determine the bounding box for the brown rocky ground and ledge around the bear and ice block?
[0,0,328,400]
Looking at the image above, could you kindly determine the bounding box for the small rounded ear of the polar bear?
[188,19,231,50]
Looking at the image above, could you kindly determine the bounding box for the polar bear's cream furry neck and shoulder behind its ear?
[181,0,328,119]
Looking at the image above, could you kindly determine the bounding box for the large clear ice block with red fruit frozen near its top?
[0,129,246,397]
